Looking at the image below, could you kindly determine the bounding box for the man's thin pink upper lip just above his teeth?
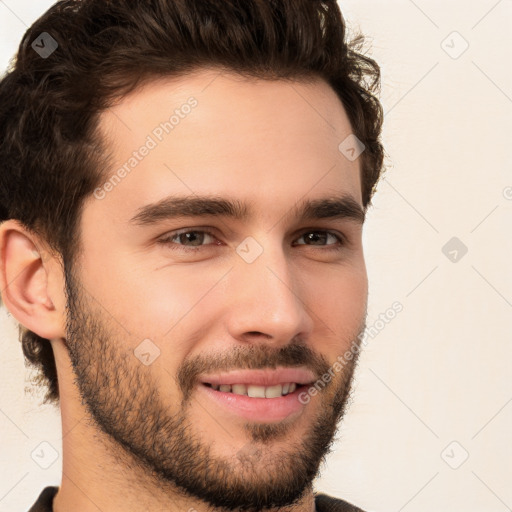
[200,368,315,387]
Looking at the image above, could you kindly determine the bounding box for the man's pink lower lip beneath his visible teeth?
[199,384,306,423]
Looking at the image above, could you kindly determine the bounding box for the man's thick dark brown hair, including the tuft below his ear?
[0,0,384,402]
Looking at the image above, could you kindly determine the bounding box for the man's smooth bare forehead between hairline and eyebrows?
[90,69,361,221]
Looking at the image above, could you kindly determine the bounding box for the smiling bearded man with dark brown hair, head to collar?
[0,0,383,512]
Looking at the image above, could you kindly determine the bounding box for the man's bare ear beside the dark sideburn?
[0,220,65,340]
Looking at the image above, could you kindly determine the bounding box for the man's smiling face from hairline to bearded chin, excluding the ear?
[66,70,367,510]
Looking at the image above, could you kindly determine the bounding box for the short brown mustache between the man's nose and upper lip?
[176,343,330,401]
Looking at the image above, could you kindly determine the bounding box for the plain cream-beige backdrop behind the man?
[0,0,512,512]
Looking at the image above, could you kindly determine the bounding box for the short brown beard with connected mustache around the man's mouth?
[65,267,365,512]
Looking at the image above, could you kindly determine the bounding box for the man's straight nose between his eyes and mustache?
[226,243,314,346]
